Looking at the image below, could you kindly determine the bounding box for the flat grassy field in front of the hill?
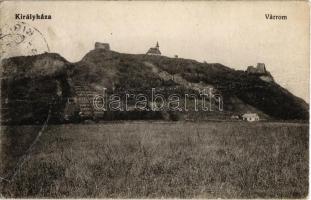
[0,122,309,198]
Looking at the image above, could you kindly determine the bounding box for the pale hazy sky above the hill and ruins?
[0,1,309,102]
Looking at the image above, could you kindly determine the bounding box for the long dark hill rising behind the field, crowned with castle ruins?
[1,49,309,123]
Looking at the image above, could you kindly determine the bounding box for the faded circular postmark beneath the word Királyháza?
[0,22,50,60]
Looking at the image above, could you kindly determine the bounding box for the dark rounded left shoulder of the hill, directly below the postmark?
[1,54,71,124]
